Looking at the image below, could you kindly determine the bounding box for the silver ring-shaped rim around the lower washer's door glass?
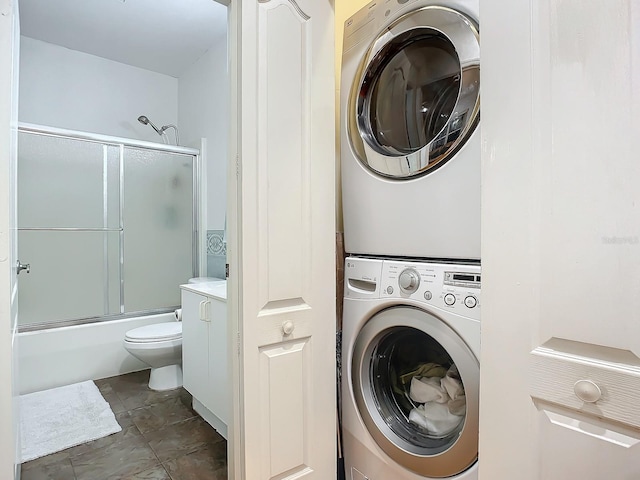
[350,305,480,478]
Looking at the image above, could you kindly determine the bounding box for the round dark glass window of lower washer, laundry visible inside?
[369,327,467,454]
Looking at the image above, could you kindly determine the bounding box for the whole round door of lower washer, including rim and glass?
[351,306,480,478]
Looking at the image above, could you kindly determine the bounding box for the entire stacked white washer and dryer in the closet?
[341,0,481,480]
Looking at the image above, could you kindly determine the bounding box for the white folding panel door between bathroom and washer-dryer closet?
[230,0,336,480]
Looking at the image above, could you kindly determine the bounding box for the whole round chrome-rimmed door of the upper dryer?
[347,6,480,180]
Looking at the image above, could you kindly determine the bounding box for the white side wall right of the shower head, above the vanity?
[178,34,229,230]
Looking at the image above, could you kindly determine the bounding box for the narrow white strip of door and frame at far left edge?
[0,0,20,479]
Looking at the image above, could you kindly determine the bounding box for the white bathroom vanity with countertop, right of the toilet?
[180,280,231,439]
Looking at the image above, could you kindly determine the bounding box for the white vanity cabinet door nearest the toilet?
[182,290,211,403]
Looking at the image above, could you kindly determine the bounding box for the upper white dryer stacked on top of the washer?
[341,0,480,260]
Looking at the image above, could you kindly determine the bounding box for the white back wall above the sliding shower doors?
[19,36,178,143]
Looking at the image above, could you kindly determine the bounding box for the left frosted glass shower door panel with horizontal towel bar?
[18,132,121,327]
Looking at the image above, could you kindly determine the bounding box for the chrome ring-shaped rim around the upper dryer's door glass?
[346,6,480,180]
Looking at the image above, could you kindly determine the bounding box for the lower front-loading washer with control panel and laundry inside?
[342,257,480,480]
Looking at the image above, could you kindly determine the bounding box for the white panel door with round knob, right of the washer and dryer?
[479,0,640,480]
